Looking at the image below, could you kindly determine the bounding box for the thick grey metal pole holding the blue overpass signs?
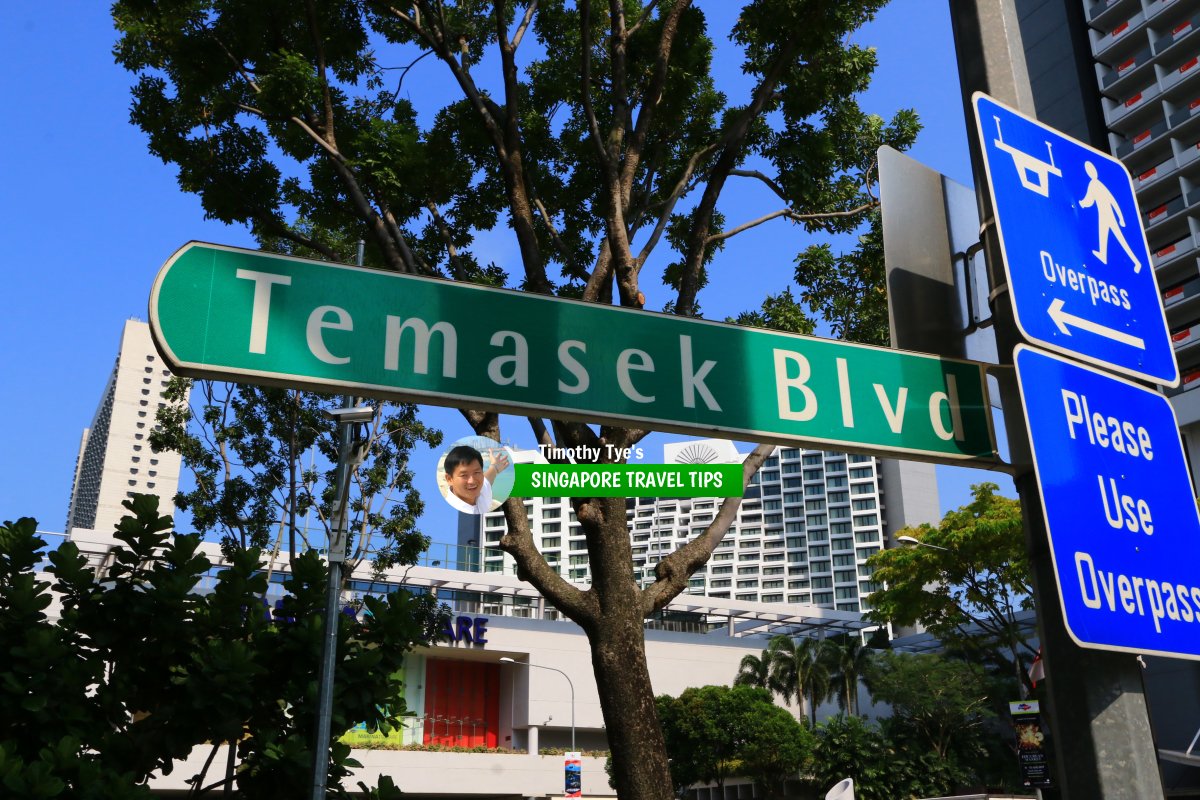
[949,0,1163,800]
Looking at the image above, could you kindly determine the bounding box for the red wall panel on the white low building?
[425,658,500,747]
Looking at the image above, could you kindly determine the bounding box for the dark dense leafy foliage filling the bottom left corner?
[0,495,440,799]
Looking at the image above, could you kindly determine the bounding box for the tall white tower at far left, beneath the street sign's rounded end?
[66,319,180,537]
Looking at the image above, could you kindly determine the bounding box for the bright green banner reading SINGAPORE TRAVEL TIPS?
[511,464,742,498]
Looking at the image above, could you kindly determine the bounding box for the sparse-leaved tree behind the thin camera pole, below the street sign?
[150,378,442,576]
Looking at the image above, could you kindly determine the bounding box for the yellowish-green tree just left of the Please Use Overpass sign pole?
[868,483,1036,688]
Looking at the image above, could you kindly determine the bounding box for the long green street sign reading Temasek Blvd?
[150,242,995,463]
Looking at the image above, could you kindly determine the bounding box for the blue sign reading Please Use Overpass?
[1014,344,1200,660]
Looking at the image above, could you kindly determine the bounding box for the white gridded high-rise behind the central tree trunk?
[458,439,941,612]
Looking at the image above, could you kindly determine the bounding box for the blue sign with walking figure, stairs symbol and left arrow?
[973,92,1180,386]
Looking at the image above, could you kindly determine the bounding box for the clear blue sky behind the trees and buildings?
[0,0,1010,539]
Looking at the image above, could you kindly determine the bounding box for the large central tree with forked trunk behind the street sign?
[113,0,918,798]
